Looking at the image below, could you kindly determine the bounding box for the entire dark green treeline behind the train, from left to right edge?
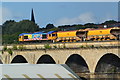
[1,20,119,44]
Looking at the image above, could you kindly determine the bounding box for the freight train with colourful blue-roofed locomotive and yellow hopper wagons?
[19,27,120,42]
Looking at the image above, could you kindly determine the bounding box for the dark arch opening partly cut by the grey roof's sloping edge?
[65,54,90,73]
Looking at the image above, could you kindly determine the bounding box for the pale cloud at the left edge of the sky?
[0,6,12,25]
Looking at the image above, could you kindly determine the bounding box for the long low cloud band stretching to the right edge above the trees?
[55,12,118,26]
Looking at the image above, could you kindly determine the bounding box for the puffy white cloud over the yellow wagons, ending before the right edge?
[55,13,96,26]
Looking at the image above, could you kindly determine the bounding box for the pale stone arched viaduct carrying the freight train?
[0,48,120,73]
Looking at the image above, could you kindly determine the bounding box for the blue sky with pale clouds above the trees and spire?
[0,2,118,27]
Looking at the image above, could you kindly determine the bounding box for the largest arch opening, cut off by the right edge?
[95,53,120,73]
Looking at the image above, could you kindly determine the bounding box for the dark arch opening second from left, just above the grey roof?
[37,55,56,64]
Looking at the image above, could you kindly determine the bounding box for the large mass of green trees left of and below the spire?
[2,20,39,44]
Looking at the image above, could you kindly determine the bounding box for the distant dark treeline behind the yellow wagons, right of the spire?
[41,20,120,31]
